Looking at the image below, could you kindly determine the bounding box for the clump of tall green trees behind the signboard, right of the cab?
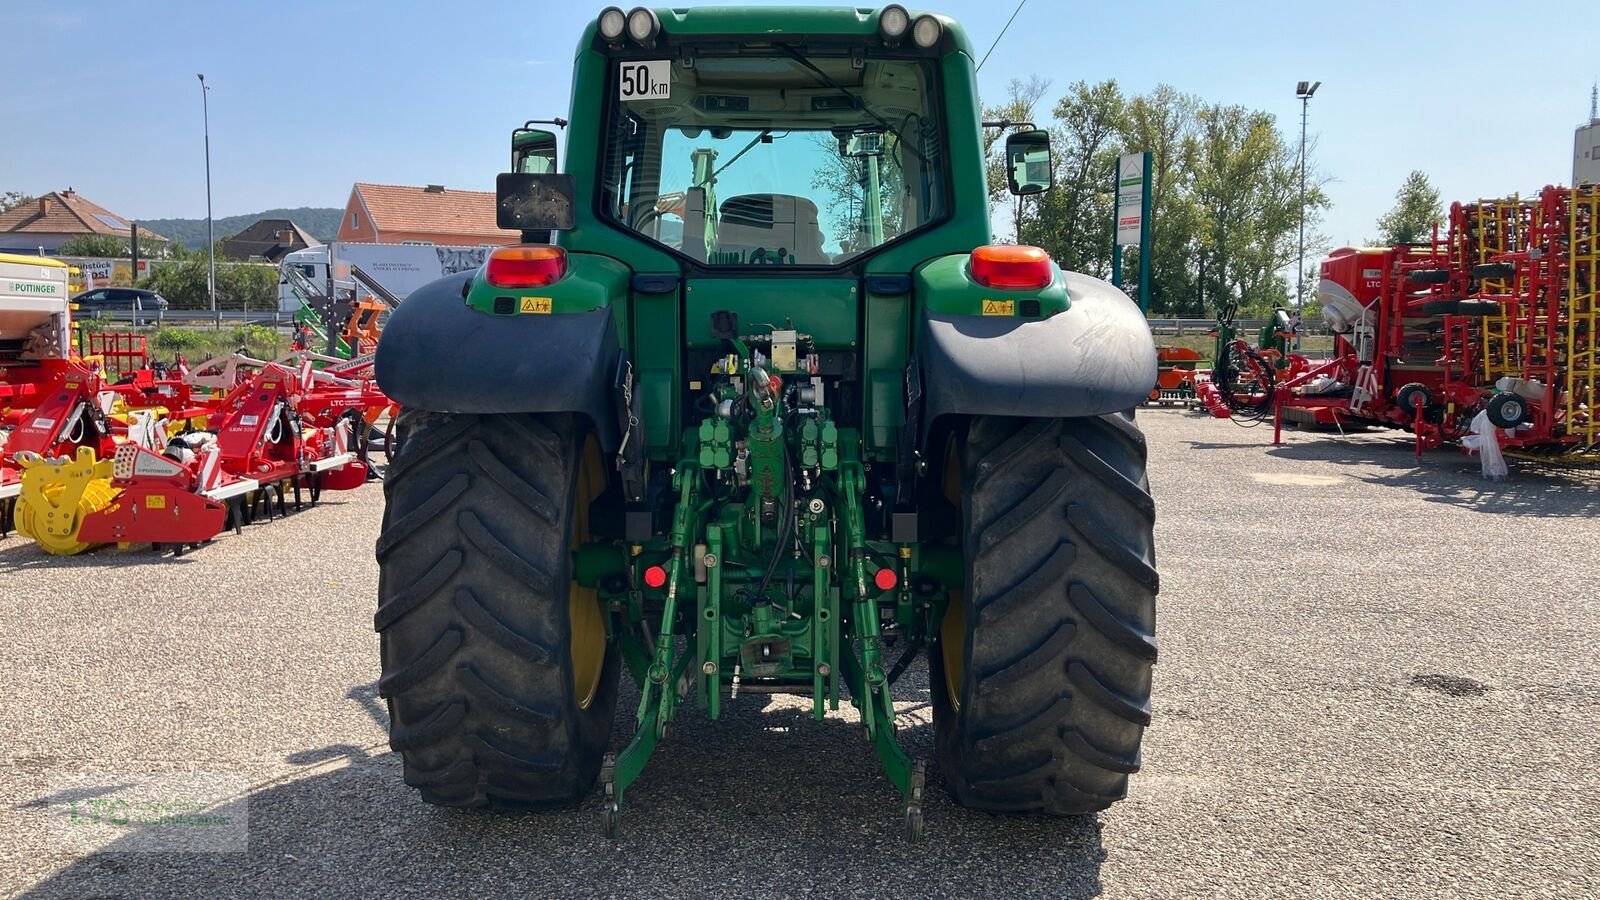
[984,77,1328,315]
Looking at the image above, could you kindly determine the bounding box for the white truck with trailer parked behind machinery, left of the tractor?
[278,240,493,312]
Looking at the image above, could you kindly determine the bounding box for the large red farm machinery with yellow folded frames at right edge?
[1210,186,1600,456]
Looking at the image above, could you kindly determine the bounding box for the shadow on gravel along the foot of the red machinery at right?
[1266,440,1600,519]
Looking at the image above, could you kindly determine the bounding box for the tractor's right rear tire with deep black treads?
[930,413,1158,815]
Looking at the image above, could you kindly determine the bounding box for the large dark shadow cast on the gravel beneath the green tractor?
[24,665,1115,898]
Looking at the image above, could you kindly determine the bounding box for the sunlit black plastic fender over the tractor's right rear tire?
[917,272,1157,437]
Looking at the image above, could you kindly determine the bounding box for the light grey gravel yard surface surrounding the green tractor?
[0,410,1600,898]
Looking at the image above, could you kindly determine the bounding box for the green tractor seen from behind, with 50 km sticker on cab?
[376,5,1157,839]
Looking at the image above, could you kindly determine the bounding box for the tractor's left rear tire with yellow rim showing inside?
[374,410,619,807]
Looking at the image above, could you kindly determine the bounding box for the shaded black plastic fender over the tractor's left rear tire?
[374,265,621,453]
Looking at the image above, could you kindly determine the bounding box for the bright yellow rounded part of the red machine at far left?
[16,447,117,556]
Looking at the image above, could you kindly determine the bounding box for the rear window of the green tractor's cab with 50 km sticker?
[600,50,950,269]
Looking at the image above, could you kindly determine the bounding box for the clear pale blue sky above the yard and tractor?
[0,0,1600,242]
